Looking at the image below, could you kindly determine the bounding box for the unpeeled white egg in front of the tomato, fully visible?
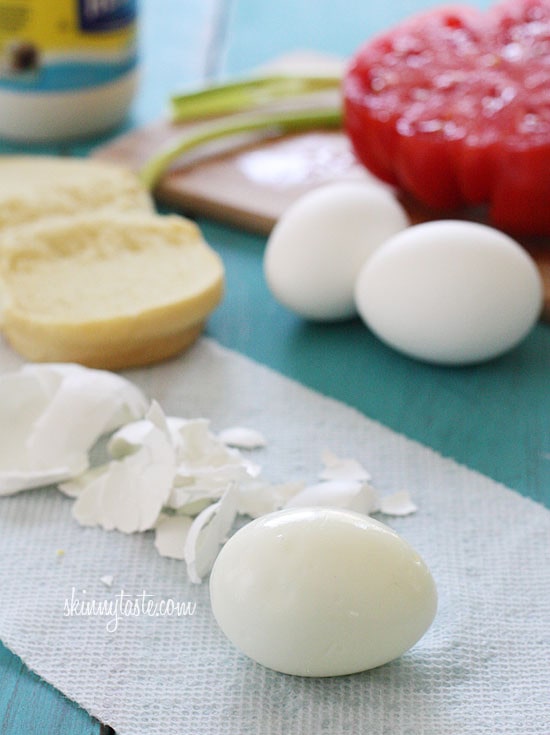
[355,220,542,365]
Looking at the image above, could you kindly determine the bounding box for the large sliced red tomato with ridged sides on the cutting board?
[344,0,550,235]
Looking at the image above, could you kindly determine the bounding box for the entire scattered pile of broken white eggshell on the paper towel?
[0,364,422,596]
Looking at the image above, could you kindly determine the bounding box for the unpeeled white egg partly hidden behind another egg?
[264,182,408,320]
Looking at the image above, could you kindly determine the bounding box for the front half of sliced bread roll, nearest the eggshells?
[0,212,224,370]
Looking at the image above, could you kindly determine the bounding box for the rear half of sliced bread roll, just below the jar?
[0,156,154,231]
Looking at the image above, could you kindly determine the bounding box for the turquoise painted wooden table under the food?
[0,0,550,735]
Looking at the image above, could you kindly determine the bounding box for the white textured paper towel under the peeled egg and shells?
[0,339,550,735]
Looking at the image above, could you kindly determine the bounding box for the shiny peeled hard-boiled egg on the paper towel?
[210,508,437,676]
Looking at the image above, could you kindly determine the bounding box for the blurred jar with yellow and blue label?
[0,0,137,142]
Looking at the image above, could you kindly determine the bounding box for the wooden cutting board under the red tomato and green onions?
[93,87,550,321]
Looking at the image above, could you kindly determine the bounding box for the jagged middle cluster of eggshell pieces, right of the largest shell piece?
[65,401,259,583]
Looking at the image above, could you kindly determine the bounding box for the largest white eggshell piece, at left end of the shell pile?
[0,363,148,495]
